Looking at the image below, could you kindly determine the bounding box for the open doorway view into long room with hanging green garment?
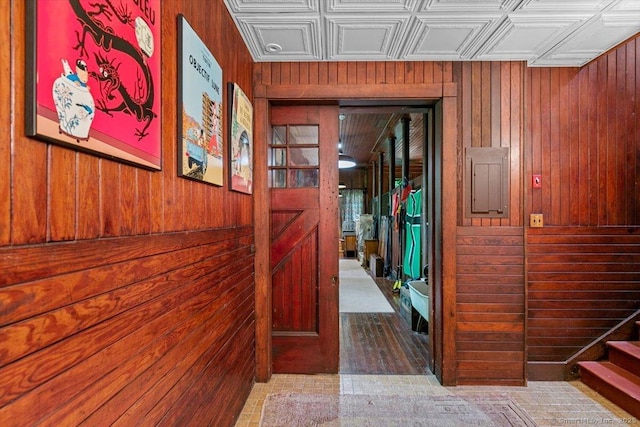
[338,102,440,375]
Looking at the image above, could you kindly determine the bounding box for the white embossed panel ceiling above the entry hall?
[224,0,640,67]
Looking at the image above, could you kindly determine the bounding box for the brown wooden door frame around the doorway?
[253,83,458,385]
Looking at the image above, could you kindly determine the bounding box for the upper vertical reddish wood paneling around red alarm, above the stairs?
[524,36,640,227]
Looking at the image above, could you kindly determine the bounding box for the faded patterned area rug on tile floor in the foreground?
[260,393,536,427]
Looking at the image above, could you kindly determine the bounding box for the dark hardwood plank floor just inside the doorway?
[340,270,431,375]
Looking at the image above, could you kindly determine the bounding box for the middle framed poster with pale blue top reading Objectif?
[178,15,224,186]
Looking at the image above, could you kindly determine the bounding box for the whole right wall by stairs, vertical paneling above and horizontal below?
[523,36,640,379]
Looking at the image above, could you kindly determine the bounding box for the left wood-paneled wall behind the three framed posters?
[0,0,255,426]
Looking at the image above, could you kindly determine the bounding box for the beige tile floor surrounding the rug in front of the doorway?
[236,374,640,427]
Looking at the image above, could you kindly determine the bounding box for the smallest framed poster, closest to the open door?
[227,83,253,194]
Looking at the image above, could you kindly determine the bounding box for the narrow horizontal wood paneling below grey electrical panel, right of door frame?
[456,227,525,384]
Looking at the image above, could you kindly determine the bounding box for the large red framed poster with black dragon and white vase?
[25,0,162,170]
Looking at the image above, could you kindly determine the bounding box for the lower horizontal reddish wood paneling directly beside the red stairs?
[527,227,640,362]
